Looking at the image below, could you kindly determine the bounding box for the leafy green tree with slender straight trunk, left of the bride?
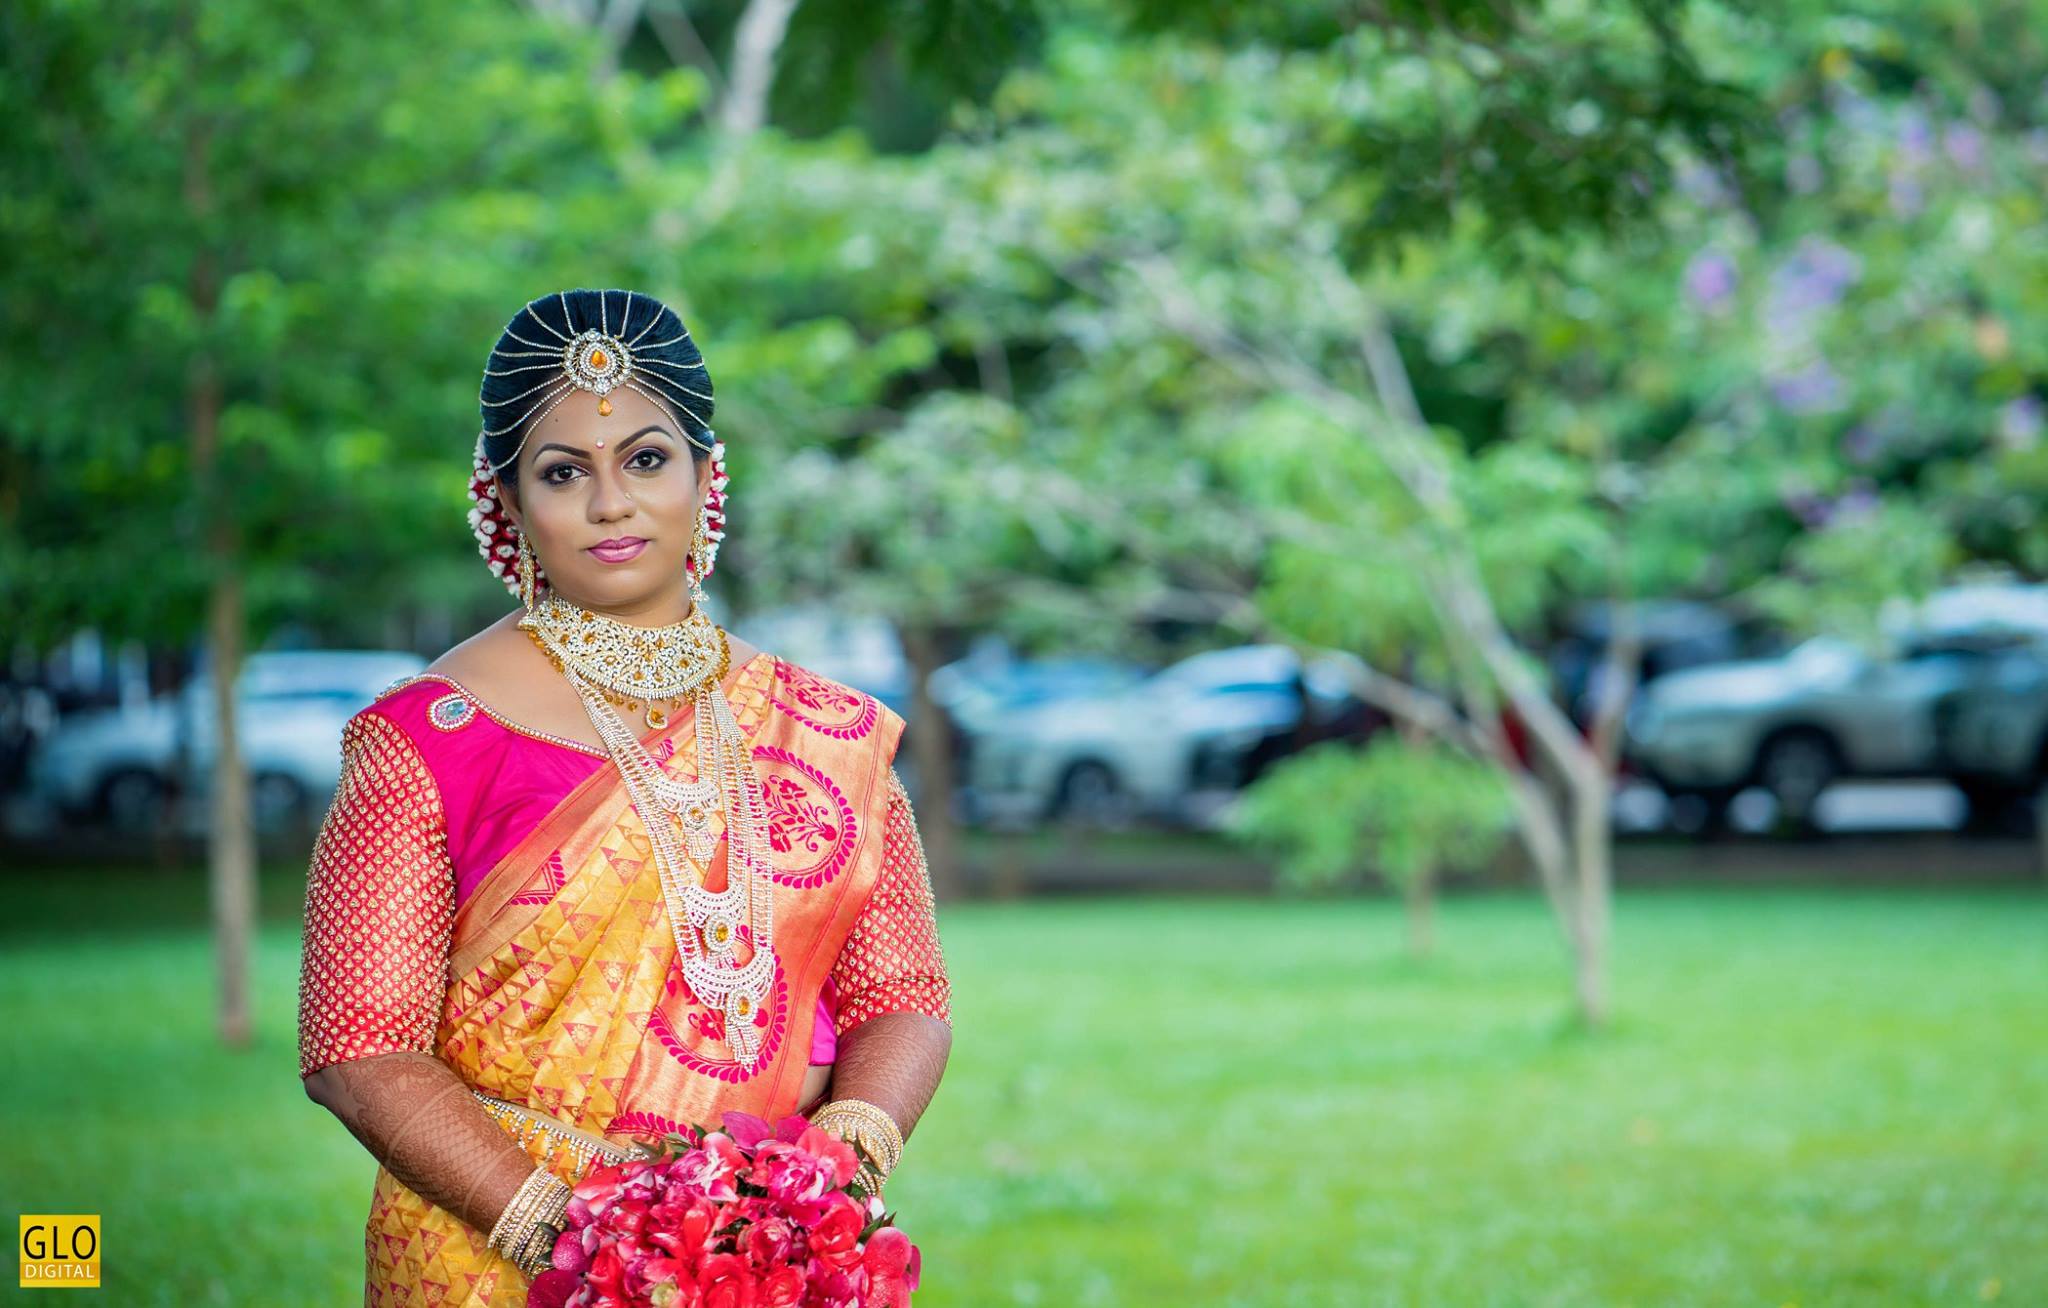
[0,2,666,1044]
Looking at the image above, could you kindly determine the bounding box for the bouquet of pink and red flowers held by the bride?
[526,1114,920,1308]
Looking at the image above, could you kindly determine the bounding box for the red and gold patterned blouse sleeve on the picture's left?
[299,710,455,1079]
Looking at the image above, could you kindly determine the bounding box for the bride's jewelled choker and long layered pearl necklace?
[520,592,774,1062]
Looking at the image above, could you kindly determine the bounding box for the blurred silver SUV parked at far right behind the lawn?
[1626,585,2048,825]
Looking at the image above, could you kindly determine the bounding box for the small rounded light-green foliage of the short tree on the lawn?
[1231,733,1513,888]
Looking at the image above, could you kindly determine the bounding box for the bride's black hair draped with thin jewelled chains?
[477,289,715,493]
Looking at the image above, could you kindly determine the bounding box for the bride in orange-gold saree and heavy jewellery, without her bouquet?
[299,291,952,1306]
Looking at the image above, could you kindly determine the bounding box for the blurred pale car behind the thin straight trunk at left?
[29,649,426,831]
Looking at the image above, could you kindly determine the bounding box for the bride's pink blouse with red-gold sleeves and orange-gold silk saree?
[299,653,952,1308]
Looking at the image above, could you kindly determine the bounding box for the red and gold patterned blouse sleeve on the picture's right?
[831,768,952,1036]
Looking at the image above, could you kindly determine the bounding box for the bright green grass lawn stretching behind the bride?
[0,870,2048,1308]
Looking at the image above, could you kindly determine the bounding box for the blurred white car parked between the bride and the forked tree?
[967,645,1358,823]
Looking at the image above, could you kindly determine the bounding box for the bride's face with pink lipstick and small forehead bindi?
[500,389,711,624]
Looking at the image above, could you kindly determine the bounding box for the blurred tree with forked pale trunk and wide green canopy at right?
[950,2,2040,1021]
